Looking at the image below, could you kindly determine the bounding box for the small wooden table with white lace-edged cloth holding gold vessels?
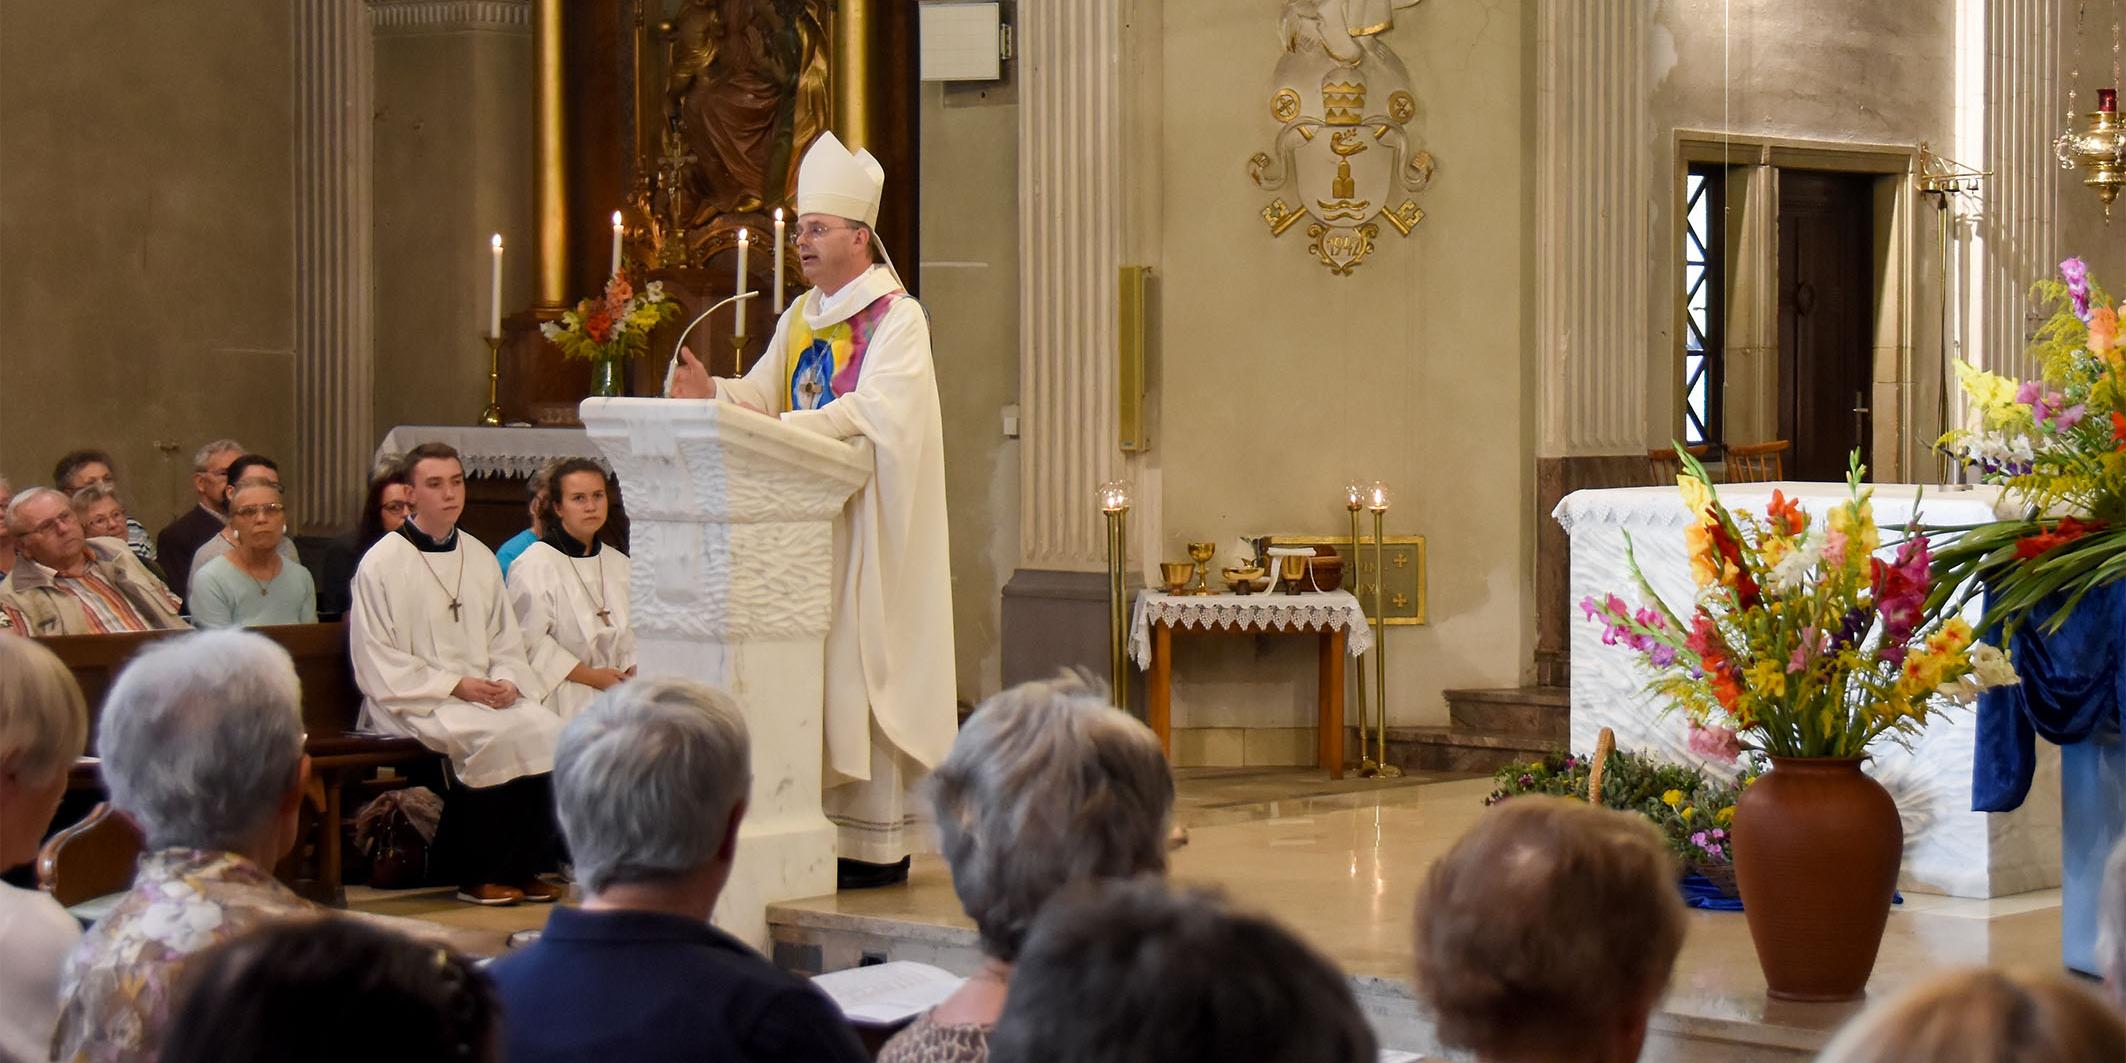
[1131,591,1373,778]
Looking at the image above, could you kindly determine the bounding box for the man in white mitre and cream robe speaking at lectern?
[672,134,959,889]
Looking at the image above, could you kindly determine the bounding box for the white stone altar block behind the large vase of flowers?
[1552,483,2060,897]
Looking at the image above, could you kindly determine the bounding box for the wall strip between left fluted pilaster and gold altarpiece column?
[374,28,536,438]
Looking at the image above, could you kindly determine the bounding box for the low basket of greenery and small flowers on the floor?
[1484,750,1758,895]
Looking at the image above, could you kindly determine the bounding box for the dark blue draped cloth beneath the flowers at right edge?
[1971,580,2126,812]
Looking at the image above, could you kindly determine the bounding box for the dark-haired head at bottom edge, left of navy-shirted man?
[159,918,504,1063]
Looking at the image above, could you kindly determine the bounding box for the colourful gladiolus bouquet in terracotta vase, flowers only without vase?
[1582,446,2015,759]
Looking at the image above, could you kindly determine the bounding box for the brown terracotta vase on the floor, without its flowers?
[1735,757,1905,1001]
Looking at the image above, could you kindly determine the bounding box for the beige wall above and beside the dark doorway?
[1646,0,1958,472]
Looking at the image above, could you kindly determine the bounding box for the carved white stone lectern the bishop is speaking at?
[583,398,872,948]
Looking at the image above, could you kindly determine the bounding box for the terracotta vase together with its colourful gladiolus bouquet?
[1582,446,2015,1001]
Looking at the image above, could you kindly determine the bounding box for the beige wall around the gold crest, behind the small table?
[1148,0,1533,727]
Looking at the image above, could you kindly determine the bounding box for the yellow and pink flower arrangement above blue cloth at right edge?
[1926,259,2126,634]
